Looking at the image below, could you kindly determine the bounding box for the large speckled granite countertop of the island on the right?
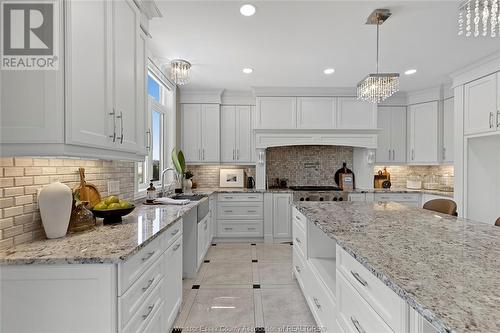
[295,202,500,333]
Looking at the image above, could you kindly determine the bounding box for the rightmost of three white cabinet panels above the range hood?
[337,97,377,129]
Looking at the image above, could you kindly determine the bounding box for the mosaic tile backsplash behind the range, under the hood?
[266,145,353,186]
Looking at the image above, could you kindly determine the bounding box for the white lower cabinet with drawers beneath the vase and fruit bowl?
[0,220,182,333]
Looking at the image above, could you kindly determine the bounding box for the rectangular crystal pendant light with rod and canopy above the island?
[358,9,399,103]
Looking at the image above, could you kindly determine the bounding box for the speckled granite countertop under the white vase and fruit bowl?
[0,198,208,265]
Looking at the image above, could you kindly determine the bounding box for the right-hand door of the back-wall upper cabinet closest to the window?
[201,104,220,163]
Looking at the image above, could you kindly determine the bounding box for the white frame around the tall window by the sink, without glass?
[134,66,176,199]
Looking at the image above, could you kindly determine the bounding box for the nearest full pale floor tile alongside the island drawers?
[261,287,314,332]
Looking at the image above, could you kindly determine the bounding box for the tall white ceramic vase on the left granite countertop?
[38,182,73,238]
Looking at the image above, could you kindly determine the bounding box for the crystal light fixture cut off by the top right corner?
[458,0,500,38]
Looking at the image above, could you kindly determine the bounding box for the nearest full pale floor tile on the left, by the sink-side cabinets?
[185,288,255,328]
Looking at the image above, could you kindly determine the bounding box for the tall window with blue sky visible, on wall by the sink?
[137,70,175,192]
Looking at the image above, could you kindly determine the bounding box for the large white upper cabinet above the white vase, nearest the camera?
[1,0,146,159]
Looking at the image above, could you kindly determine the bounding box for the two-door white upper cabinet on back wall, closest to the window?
[181,104,220,163]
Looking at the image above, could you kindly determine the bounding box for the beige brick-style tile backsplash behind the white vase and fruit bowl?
[0,157,134,248]
